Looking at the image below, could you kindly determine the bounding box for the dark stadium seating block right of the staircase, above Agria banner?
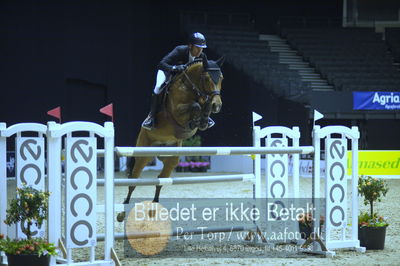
[281,27,400,91]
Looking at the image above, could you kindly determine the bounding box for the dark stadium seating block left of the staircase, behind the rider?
[189,26,311,103]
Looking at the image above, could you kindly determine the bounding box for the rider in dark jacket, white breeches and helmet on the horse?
[142,32,214,130]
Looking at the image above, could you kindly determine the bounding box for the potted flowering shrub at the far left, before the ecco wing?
[0,185,57,266]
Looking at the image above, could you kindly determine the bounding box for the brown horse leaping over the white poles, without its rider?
[117,57,223,222]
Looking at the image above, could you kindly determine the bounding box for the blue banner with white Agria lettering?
[353,91,400,110]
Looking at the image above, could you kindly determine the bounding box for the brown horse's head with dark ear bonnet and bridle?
[201,56,224,113]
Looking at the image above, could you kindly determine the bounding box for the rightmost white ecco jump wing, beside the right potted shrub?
[313,126,365,252]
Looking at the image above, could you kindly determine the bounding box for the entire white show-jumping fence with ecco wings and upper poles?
[0,122,363,265]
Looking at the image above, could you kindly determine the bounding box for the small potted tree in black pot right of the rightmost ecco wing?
[358,176,389,249]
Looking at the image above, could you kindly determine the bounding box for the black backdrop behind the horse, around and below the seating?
[0,0,396,146]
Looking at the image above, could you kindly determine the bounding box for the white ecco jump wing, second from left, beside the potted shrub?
[48,122,114,265]
